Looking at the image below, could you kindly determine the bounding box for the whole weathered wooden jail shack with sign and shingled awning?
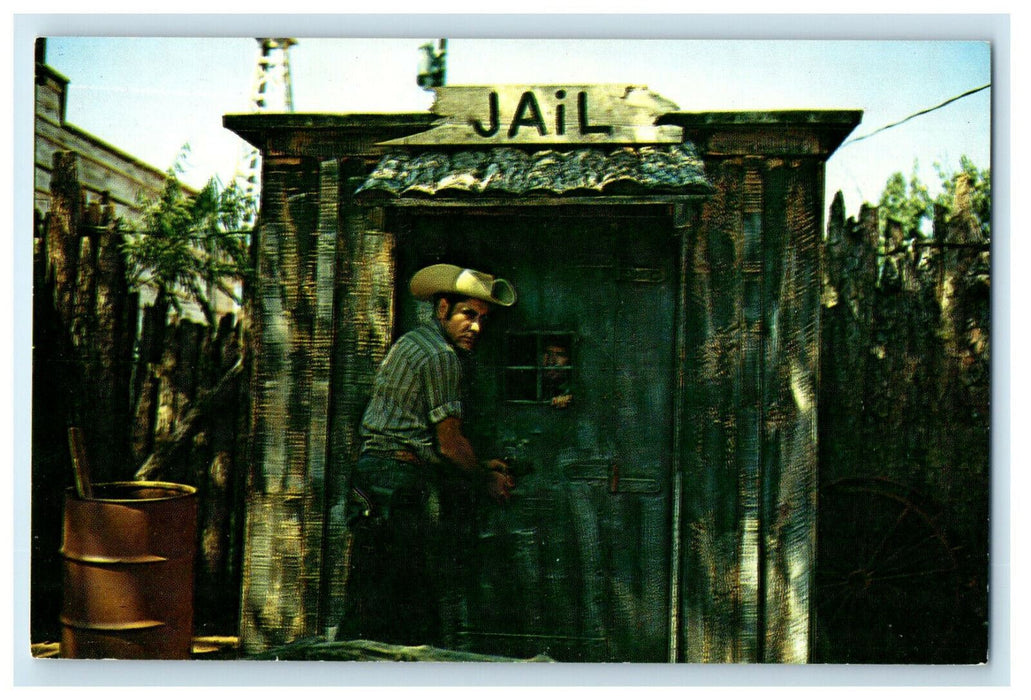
[224,86,861,663]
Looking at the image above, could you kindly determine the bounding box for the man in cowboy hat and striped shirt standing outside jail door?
[336,265,516,644]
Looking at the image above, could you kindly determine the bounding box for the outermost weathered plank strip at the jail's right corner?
[760,159,824,663]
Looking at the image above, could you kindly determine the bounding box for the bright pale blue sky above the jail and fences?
[40,29,992,214]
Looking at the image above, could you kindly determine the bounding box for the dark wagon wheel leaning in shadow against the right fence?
[814,478,960,663]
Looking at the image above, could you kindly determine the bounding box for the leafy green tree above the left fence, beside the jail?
[124,161,251,326]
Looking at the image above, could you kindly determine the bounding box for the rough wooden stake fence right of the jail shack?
[817,176,991,663]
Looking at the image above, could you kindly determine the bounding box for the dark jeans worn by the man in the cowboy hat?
[336,456,444,645]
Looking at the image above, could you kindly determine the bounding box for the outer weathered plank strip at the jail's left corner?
[240,157,335,653]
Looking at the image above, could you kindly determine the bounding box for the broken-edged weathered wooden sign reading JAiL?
[386,85,681,145]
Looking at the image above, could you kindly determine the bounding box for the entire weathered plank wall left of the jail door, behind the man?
[240,153,394,653]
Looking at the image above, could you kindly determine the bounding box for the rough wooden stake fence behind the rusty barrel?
[31,153,248,640]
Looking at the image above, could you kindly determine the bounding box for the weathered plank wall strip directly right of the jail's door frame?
[679,153,756,663]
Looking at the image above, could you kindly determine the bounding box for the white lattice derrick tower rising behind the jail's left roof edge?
[234,37,297,226]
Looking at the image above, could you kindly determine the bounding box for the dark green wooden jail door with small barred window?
[398,207,677,662]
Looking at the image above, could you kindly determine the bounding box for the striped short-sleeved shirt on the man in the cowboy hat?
[361,322,462,463]
